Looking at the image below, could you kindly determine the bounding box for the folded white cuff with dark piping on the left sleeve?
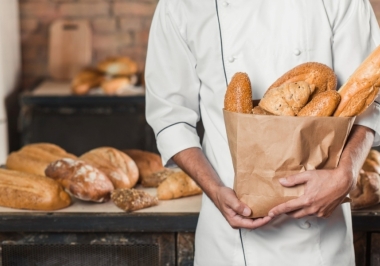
[156,123,201,166]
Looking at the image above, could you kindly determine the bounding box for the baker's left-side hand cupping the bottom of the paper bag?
[214,187,272,229]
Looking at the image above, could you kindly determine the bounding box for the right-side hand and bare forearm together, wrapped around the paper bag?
[269,125,374,218]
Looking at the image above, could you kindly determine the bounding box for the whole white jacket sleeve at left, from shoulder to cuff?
[145,0,201,165]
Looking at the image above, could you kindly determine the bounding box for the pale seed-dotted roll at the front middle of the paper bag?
[259,81,315,116]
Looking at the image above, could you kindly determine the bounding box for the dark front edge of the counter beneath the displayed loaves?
[0,210,380,233]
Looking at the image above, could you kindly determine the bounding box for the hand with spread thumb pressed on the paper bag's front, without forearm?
[269,169,355,218]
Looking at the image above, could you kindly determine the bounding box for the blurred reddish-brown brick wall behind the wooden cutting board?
[18,0,158,89]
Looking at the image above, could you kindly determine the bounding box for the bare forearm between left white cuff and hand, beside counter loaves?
[172,148,224,200]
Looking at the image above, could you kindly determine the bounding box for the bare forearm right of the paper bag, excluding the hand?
[338,125,374,189]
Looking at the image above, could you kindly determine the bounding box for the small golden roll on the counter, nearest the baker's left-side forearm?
[157,171,202,200]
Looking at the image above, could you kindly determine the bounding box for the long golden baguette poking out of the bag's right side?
[334,46,380,117]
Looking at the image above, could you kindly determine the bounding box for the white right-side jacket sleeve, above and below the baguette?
[332,0,380,146]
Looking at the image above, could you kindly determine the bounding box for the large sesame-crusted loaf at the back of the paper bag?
[268,62,337,98]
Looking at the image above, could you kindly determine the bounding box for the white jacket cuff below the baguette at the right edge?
[354,102,380,147]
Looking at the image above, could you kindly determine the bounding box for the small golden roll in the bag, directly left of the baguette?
[297,90,340,116]
